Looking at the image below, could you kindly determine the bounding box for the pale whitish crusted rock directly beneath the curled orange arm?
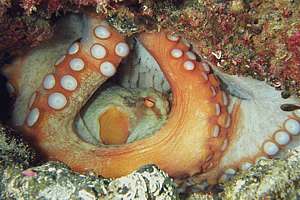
[2,162,177,200]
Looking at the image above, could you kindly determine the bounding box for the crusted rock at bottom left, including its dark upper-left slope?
[0,125,177,200]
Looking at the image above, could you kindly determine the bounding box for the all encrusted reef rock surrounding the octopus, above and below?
[0,0,300,199]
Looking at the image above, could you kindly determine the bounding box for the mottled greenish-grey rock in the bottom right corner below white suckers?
[188,148,300,200]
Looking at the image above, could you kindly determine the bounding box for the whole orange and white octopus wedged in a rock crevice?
[2,13,300,188]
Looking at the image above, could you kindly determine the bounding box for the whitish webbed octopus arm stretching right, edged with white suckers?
[191,63,300,183]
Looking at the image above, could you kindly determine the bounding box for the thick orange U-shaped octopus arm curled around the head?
[19,13,232,177]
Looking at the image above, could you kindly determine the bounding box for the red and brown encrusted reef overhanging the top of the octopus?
[0,0,300,93]
